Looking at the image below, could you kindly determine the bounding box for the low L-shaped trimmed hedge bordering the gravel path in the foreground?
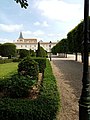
[0,60,59,120]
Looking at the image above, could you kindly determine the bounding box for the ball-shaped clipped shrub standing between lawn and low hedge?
[18,57,39,80]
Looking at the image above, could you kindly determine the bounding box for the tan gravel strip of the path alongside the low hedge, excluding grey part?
[51,61,81,120]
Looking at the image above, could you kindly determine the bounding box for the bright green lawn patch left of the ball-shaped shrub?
[0,62,18,78]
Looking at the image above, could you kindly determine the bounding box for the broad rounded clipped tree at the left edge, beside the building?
[0,43,16,57]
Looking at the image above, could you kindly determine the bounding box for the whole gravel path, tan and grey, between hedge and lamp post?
[51,59,82,120]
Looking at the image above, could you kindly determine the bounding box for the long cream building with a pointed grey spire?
[14,32,57,52]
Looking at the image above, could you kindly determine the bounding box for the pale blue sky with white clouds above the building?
[0,0,87,43]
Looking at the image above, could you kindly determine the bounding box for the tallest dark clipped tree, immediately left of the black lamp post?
[67,21,83,53]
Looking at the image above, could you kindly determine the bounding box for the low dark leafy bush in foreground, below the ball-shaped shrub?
[0,74,36,98]
